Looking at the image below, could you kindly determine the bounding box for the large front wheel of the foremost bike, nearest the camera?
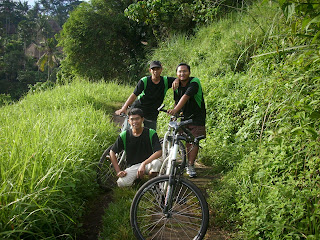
[130,176,209,240]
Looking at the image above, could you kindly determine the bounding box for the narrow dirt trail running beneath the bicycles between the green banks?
[76,116,230,240]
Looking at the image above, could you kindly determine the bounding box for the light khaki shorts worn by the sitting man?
[117,159,162,187]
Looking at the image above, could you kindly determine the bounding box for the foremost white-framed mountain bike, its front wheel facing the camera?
[130,106,209,240]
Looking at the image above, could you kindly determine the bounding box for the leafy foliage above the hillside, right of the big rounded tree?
[125,0,258,42]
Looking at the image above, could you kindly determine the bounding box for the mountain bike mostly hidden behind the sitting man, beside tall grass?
[97,114,130,190]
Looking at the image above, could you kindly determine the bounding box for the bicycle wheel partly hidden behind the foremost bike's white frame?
[159,139,187,175]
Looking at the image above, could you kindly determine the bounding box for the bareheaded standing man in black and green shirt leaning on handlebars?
[168,63,206,177]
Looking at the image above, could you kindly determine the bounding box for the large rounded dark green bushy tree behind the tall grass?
[59,0,144,81]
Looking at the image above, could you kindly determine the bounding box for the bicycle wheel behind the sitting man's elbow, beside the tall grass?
[97,145,126,190]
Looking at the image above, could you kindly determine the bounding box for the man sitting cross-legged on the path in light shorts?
[110,108,162,187]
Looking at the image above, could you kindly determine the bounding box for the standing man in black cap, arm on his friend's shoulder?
[116,61,179,130]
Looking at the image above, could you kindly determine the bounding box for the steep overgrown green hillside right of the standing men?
[151,1,320,239]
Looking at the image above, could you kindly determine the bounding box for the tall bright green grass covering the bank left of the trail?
[0,81,131,239]
